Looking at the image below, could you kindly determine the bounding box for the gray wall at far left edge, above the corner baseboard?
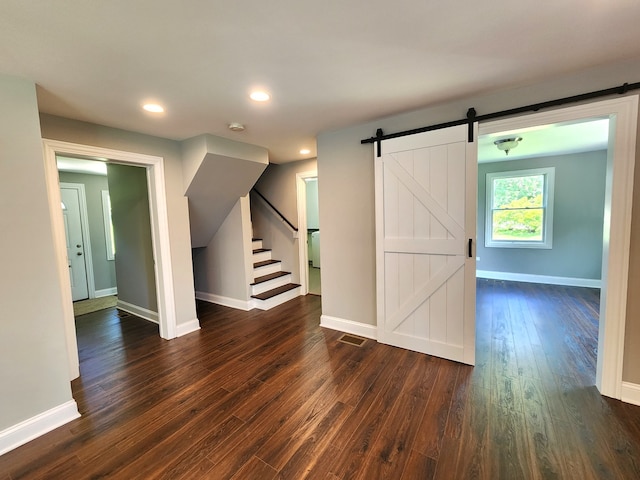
[0,75,72,431]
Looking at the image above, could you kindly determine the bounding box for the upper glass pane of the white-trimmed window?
[493,174,544,208]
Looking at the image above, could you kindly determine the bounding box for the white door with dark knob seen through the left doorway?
[60,188,89,302]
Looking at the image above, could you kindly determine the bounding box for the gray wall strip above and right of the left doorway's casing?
[40,114,196,325]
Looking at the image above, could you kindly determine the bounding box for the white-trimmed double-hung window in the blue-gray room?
[485,167,555,248]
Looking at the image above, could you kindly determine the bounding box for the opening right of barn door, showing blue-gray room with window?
[476,118,610,385]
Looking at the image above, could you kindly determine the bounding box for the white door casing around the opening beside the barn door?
[478,96,638,399]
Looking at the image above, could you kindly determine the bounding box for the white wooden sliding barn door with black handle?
[375,125,477,365]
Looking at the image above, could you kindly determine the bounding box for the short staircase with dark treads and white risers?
[251,238,300,310]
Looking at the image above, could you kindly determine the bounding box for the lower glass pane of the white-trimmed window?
[491,208,544,242]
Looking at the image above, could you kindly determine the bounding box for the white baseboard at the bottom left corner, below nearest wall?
[0,400,80,455]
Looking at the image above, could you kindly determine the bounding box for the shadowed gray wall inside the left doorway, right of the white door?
[107,164,158,313]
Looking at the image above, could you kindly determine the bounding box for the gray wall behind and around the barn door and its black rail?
[318,60,640,383]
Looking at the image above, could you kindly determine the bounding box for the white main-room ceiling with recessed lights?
[0,0,640,162]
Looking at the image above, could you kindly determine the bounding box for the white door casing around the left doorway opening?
[43,139,176,379]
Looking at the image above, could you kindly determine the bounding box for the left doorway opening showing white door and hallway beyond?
[57,156,158,323]
